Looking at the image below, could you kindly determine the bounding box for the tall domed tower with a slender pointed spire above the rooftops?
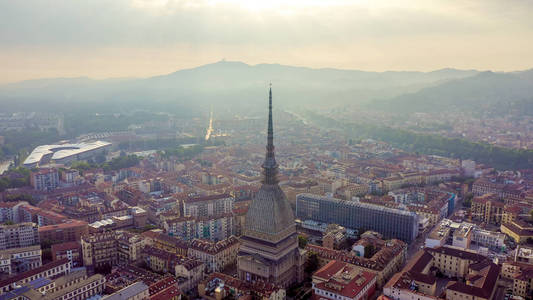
[237,87,304,287]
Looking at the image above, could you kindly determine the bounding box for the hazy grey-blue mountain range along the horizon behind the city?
[0,61,533,115]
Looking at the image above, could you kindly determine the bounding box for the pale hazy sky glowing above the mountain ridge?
[0,0,533,82]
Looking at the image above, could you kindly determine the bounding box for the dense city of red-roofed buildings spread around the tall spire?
[0,84,533,300]
